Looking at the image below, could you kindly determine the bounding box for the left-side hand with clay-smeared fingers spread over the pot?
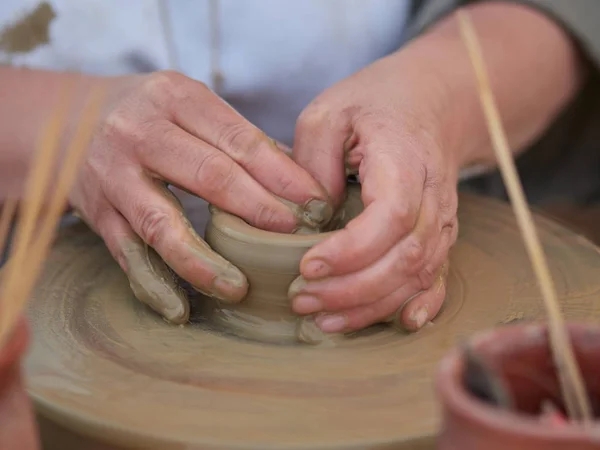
[70,72,331,324]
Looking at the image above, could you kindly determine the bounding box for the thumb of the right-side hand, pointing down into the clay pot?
[292,100,352,207]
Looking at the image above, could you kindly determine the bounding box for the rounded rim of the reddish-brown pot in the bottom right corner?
[435,322,600,440]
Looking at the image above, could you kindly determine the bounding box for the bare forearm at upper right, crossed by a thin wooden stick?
[394,2,584,167]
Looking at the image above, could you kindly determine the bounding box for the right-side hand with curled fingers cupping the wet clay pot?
[292,54,458,332]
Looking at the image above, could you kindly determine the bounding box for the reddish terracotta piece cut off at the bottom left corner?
[0,320,39,450]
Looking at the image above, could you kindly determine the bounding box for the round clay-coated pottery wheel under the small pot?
[21,196,600,449]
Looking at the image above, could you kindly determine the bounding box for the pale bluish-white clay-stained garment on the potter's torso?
[0,0,410,145]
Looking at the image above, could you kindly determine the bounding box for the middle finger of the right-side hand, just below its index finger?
[292,193,440,314]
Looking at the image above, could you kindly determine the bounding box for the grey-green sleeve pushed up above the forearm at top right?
[407,0,600,69]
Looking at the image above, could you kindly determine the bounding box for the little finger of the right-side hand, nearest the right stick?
[398,264,448,331]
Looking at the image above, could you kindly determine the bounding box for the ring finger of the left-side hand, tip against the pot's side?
[107,170,248,302]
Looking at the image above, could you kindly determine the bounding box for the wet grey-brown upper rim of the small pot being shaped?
[209,205,339,248]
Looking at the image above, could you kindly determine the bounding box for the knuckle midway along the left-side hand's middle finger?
[196,152,235,198]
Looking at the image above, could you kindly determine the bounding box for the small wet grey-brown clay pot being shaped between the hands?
[206,185,363,344]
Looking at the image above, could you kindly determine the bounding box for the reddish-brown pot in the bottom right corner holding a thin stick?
[436,324,600,450]
